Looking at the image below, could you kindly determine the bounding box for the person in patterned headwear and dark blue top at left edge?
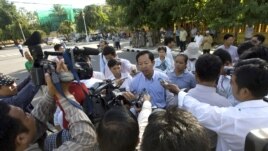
[0,74,39,112]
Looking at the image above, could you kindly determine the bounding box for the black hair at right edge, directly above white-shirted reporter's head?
[239,46,268,62]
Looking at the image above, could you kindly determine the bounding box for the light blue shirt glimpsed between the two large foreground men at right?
[216,75,240,106]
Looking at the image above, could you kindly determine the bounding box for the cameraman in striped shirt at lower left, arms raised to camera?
[0,62,97,151]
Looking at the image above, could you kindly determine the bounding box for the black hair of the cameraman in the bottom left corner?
[0,101,29,151]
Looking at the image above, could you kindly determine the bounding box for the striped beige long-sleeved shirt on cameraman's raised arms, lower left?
[32,94,98,151]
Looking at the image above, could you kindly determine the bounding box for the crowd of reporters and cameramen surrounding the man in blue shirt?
[0,27,268,151]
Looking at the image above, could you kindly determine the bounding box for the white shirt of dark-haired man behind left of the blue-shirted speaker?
[104,58,135,79]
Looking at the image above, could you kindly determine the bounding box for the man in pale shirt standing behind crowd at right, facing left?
[217,34,239,63]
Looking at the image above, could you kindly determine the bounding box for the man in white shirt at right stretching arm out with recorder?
[164,58,268,151]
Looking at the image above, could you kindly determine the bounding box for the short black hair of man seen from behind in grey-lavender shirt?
[195,54,222,81]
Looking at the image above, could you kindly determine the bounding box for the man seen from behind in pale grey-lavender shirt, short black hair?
[188,54,231,150]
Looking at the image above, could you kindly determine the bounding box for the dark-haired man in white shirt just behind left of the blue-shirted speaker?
[102,46,137,78]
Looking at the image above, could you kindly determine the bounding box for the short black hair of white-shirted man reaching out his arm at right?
[233,58,268,99]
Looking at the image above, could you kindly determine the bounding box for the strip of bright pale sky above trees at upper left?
[8,0,105,11]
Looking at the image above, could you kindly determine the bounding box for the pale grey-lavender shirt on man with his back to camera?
[188,84,231,148]
